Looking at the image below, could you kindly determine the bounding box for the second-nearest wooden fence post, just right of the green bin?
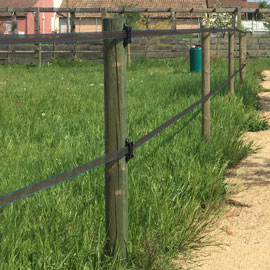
[202,25,211,140]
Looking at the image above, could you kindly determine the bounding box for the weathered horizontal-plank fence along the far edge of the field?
[0,37,270,64]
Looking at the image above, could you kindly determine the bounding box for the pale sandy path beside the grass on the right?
[177,71,270,270]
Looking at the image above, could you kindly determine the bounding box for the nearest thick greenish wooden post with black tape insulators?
[103,18,128,261]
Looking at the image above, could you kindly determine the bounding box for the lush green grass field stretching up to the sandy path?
[0,56,270,270]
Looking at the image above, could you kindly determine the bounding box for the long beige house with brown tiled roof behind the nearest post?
[59,0,206,32]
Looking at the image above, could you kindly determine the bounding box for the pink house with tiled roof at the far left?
[0,0,55,34]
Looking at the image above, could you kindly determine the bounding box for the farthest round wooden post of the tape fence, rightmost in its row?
[237,8,246,83]
